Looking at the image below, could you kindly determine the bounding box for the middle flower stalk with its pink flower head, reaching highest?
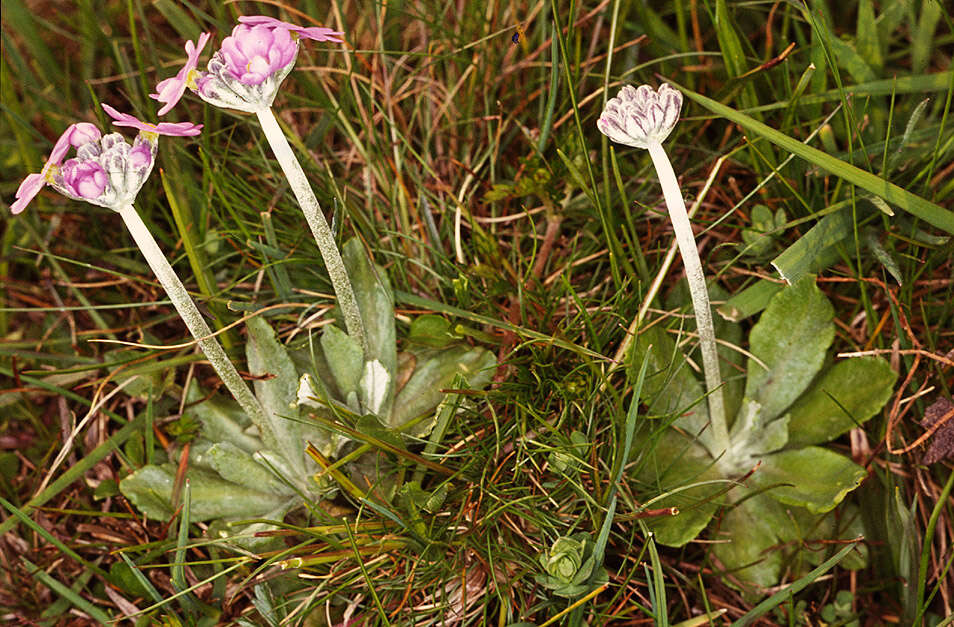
[152,15,367,352]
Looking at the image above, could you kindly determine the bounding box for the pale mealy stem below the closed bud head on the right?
[649,142,729,455]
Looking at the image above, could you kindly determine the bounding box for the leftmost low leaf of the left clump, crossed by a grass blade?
[119,464,287,522]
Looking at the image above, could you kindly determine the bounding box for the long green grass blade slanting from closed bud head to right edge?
[669,81,954,233]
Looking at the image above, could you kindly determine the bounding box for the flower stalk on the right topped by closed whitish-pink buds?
[596,83,729,451]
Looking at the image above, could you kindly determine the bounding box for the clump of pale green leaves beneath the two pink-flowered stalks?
[120,239,496,546]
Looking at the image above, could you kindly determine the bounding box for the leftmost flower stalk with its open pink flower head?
[11,109,269,446]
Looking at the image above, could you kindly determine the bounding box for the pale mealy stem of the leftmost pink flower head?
[118,205,274,447]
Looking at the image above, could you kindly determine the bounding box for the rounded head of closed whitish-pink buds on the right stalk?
[596,83,682,148]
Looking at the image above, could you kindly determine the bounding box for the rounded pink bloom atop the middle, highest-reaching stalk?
[222,24,298,85]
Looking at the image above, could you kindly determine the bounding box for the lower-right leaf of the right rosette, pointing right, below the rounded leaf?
[752,446,867,513]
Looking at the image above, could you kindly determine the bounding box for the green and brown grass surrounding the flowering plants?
[0,0,954,625]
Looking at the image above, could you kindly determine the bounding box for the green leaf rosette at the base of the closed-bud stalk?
[634,276,896,586]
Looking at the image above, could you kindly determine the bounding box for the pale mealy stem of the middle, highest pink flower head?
[257,108,368,355]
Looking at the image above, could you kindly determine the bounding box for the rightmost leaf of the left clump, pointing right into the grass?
[386,346,497,436]
